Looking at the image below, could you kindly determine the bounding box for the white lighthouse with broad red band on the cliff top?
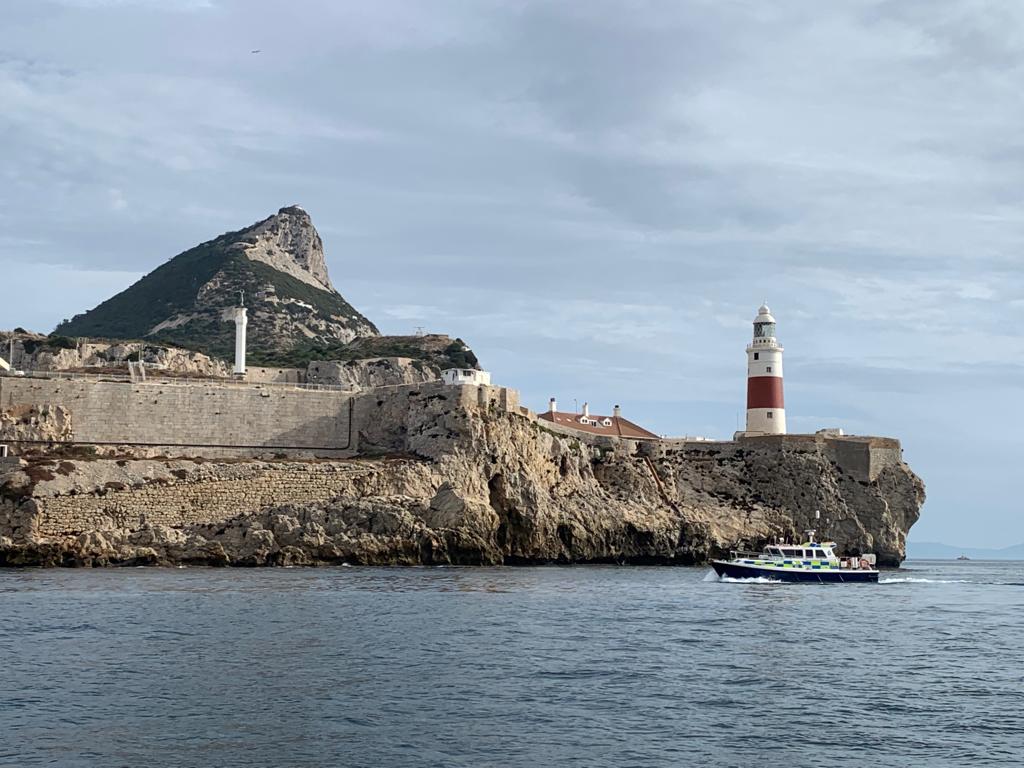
[746,304,785,435]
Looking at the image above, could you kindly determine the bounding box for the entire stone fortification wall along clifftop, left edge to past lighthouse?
[0,370,902,482]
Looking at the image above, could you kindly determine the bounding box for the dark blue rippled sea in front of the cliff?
[0,562,1024,768]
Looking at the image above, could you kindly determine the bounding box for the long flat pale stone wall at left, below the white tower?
[0,377,355,455]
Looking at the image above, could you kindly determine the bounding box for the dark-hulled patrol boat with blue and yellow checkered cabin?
[712,530,879,584]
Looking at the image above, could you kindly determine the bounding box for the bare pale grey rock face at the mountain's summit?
[238,206,335,291]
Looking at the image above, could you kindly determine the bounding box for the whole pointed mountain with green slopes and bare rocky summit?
[56,206,379,365]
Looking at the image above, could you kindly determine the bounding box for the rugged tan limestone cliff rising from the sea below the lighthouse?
[0,384,924,565]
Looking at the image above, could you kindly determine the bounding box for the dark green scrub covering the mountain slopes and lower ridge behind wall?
[45,209,477,369]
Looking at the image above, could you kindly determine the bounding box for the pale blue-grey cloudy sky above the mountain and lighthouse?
[0,0,1024,547]
